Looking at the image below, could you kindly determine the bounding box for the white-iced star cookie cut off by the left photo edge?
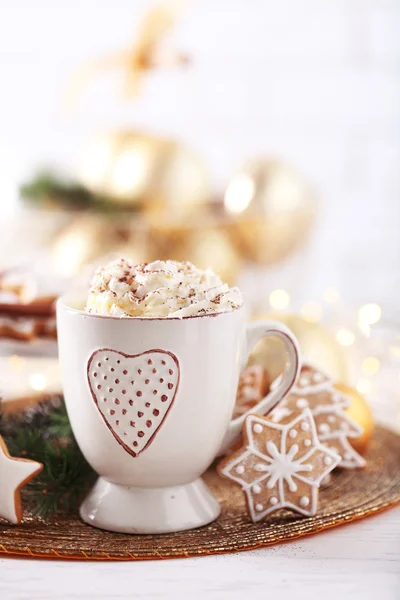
[0,436,43,525]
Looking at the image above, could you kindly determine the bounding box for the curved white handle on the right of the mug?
[218,321,301,456]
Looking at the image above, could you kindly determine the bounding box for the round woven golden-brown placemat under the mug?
[0,427,400,561]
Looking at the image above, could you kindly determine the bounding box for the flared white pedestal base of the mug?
[80,477,221,534]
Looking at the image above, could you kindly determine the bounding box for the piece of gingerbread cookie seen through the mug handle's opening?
[233,365,270,417]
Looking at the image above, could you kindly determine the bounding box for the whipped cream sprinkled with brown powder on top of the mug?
[85,258,242,318]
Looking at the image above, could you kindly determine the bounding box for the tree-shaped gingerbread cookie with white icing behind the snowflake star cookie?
[270,363,366,469]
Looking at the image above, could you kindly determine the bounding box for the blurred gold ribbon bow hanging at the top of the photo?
[65,1,188,110]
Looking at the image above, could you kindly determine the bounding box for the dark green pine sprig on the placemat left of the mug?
[0,403,95,517]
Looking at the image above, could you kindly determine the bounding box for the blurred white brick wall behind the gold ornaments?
[0,0,400,305]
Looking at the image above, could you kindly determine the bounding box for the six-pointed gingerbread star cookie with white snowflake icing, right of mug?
[218,409,340,522]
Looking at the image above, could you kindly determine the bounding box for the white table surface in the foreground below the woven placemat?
[0,506,400,600]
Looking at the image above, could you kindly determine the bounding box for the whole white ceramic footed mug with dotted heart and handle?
[57,296,299,533]
